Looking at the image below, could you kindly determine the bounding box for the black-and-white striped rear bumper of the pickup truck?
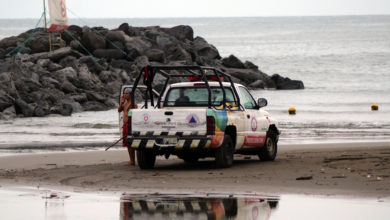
[127,136,211,150]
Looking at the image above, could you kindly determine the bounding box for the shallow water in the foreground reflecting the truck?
[0,188,390,220]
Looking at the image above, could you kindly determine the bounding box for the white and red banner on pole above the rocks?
[47,0,68,31]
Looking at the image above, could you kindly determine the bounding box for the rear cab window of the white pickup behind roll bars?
[164,87,236,106]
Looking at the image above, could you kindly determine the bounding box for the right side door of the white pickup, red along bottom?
[238,86,265,147]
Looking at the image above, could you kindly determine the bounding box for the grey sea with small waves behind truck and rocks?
[0,16,390,148]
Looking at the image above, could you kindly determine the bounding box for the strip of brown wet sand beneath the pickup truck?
[0,143,390,198]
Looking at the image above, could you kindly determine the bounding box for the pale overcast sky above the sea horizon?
[0,0,390,18]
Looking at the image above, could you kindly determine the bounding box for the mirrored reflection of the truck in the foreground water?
[120,195,279,220]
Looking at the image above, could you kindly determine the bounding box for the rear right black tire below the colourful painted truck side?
[215,135,234,168]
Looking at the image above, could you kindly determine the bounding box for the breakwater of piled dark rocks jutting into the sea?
[0,23,304,119]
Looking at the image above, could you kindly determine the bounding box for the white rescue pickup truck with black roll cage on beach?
[122,66,280,169]
